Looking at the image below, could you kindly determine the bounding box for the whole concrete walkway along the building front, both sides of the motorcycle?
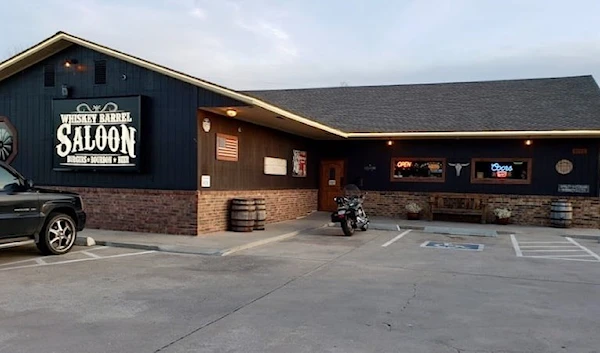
[78,212,600,256]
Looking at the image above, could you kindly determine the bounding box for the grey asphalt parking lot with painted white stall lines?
[0,227,600,353]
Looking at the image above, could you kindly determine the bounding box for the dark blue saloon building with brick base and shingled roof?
[0,32,600,235]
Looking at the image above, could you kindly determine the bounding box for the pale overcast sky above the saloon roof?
[0,0,600,90]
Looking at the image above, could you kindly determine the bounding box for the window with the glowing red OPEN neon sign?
[391,157,446,183]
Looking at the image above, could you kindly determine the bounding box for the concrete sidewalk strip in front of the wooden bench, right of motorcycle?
[370,213,600,241]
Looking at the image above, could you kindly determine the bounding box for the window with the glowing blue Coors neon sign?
[471,158,531,184]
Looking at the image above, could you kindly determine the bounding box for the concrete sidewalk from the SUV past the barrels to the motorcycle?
[78,212,329,256]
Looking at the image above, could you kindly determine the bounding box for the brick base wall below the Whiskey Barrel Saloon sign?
[50,187,198,235]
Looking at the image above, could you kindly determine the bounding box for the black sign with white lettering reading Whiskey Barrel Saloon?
[52,96,141,171]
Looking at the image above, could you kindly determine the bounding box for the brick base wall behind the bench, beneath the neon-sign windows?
[364,191,600,228]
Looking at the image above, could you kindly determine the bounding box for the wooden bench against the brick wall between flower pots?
[429,194,487,223]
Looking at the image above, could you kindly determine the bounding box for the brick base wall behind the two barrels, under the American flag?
[198,189,318,234]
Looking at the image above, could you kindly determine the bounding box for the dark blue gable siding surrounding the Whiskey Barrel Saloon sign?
[0,46,246,190]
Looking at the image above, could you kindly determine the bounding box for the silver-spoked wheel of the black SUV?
[37,213,77,255]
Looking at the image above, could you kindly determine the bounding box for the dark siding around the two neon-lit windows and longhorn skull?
[321,139,599,196]
